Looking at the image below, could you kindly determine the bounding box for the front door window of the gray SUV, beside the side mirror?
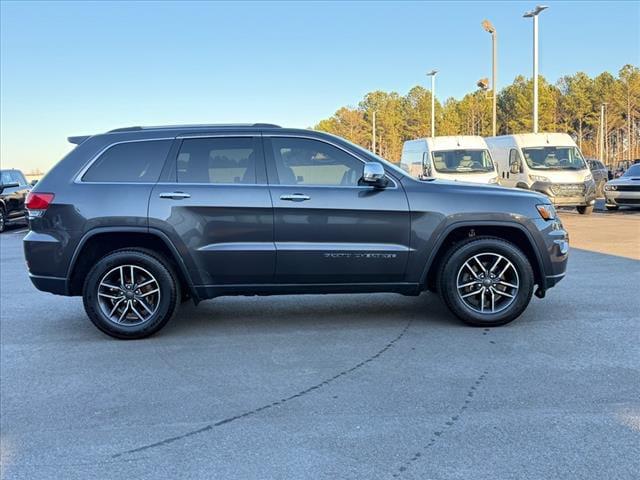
[271,137,364,186]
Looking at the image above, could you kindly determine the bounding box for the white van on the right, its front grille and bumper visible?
[486,133,596,214]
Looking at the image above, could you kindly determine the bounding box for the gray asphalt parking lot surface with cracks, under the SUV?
[0,212,640,480]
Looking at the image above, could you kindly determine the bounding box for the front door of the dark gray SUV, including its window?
[264,134,410,284]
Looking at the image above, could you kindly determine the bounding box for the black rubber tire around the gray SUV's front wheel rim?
[437,237,535,327]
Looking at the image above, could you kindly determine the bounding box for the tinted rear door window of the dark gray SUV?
[178,137,257,184]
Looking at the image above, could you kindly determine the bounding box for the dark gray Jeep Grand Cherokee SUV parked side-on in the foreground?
[24,124,569,338]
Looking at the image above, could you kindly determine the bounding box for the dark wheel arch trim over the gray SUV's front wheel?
[420,221,545,290]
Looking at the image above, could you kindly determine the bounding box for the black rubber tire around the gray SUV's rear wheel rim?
[82,249,181,340]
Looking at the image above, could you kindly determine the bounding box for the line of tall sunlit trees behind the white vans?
[315,65,640,165]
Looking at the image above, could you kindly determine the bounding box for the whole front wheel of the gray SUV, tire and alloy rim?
[438,237,534,327]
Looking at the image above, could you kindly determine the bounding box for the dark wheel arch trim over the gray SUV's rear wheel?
[67,227,199,302]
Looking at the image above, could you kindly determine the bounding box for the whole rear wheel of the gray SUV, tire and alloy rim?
[82,249,181,339]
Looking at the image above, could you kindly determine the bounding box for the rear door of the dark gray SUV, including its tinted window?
[149,133,275,285]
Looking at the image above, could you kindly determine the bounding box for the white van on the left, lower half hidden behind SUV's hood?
[400,135,498,183]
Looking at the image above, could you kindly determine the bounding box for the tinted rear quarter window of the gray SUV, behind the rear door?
[82,140,171,182]
